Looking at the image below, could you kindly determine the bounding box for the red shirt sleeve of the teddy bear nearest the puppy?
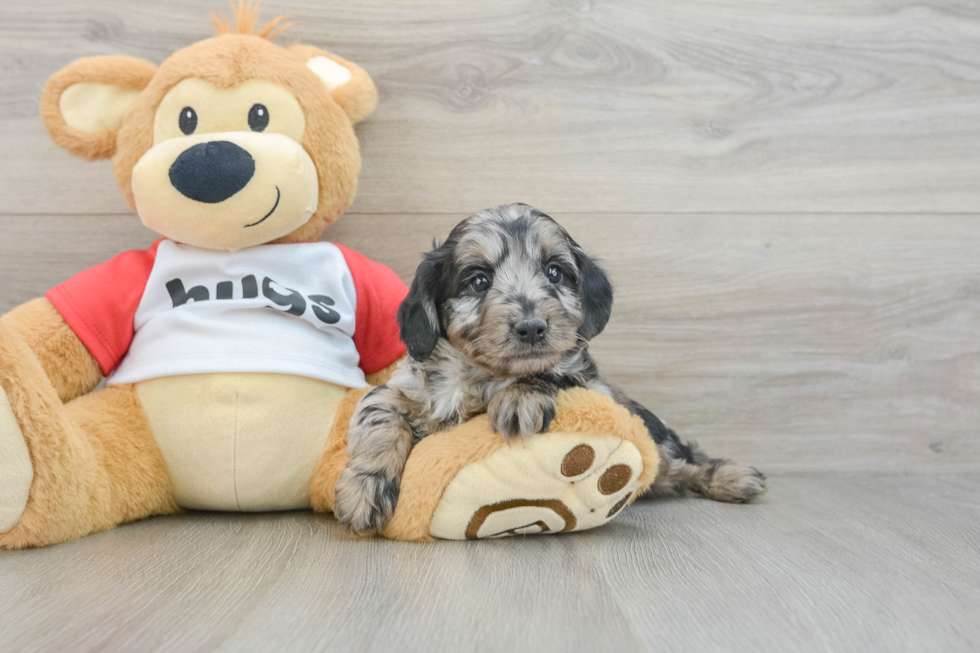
[335,243,408,374]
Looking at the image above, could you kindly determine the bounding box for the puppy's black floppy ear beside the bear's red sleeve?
[398,249,444,361]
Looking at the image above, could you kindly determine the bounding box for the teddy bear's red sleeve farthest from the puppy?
[45,240,160,376]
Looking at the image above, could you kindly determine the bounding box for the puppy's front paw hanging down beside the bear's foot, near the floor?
[334,467,400,536]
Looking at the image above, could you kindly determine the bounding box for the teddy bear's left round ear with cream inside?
[41,56,156,161]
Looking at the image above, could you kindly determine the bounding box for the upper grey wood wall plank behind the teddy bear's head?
[0,0,980,213]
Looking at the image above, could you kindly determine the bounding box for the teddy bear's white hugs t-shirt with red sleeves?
[46,239,406,388]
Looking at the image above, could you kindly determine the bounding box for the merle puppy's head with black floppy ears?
[398,204,612,376]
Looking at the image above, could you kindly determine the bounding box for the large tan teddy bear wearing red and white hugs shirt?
[0,3,659,548]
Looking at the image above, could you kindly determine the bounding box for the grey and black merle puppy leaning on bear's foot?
[335,204,766,534]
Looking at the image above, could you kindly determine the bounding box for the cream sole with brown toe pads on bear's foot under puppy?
[430,433,643,540]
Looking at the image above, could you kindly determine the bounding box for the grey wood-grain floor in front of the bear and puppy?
[0,474,980,653]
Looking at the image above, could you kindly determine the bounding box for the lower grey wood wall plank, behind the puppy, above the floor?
[0,213,980,474]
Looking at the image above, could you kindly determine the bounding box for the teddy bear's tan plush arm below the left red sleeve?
[3,297,102,402]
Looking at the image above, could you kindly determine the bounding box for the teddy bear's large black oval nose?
[170,141,255,204]
